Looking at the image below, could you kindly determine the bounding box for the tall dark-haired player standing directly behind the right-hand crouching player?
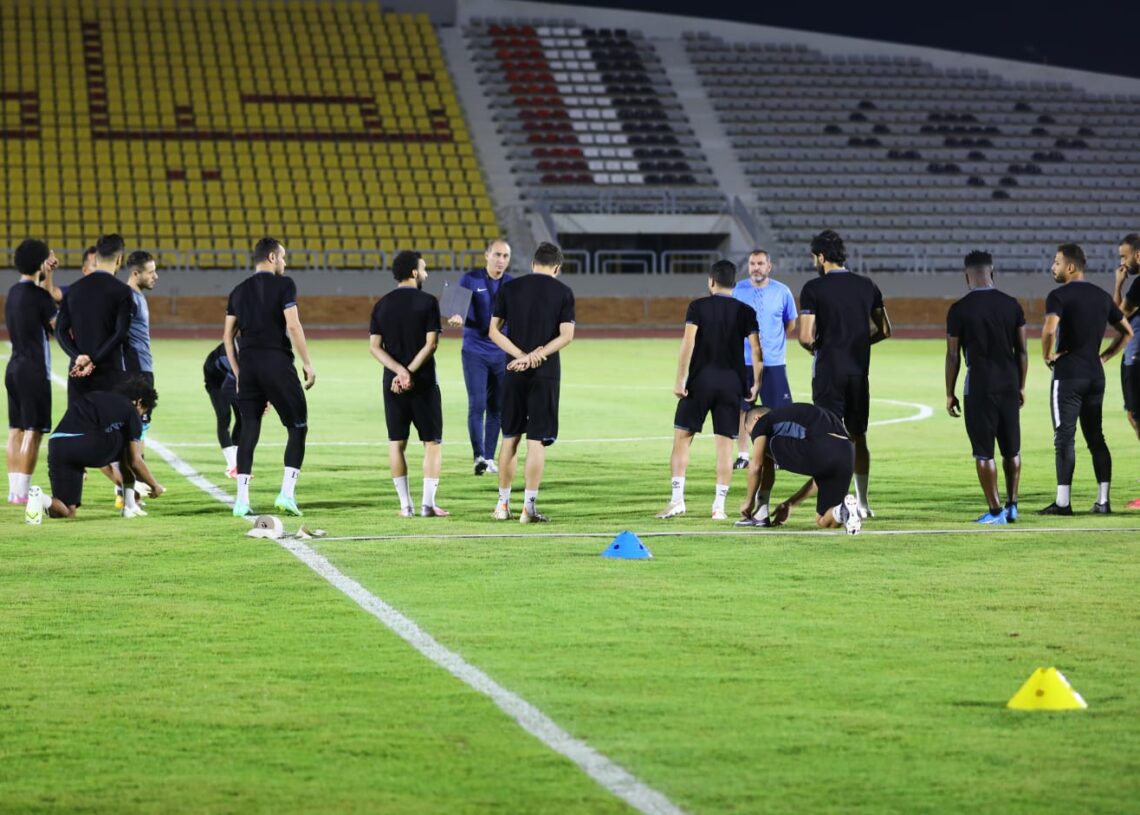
[799,229,890,517]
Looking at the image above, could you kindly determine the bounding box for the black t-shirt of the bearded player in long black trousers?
[1045,280,1124,380]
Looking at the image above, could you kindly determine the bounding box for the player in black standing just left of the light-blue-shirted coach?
[657,260,764,521]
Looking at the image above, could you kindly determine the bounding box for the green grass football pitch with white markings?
[0,337,1140,814]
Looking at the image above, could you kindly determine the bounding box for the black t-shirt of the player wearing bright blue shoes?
[946,288,1025,394]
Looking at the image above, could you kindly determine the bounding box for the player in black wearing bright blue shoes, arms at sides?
[946,252,1029,523]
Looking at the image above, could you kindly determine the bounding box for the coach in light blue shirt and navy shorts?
[732,248,797,470]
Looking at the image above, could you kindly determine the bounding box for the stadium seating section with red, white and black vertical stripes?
[464,19,725,213]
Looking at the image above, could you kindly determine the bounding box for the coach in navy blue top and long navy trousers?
[448,239,511,475]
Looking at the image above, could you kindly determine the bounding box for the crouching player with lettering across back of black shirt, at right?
[736,402,863,535]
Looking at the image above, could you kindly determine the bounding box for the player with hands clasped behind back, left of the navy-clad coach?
[368,252,449,517]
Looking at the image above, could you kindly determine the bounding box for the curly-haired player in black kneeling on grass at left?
[33,377,165,517]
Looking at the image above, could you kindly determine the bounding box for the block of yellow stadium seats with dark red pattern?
[0,0,499,268]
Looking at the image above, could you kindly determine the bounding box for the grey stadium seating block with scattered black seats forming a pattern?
[685,34,1140,271]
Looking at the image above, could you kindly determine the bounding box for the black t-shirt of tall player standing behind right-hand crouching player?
[799,269,882,376]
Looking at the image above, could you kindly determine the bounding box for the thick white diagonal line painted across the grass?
[28,360,684,815]
